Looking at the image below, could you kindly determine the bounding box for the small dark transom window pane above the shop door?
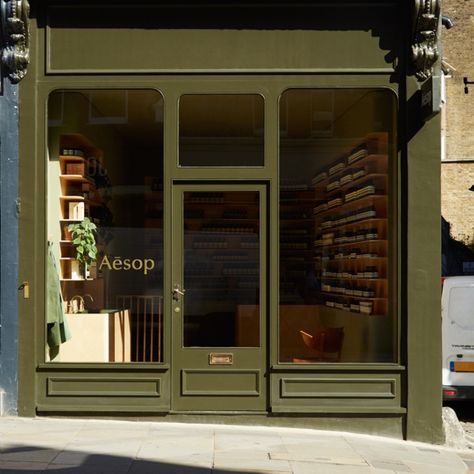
[179,94,264,166]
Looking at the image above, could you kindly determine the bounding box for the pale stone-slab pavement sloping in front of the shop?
[0,417,474,474]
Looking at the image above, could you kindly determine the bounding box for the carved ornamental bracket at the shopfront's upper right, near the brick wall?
[411,0,440,80]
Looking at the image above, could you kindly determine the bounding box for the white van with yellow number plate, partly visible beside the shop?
[441,276,474,400]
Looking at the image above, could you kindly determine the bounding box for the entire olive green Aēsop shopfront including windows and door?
[18,0,442,441]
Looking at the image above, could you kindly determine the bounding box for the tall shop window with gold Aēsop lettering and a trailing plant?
[45,90,163,362]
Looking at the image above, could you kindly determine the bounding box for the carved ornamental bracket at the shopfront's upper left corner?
[0,0,30,84]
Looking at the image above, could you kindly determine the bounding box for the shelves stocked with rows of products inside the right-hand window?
[313,133,389,316]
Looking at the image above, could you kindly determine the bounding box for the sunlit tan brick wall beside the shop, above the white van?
[441,0,474,240]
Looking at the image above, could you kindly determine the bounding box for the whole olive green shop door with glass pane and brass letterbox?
[172,183,267,412]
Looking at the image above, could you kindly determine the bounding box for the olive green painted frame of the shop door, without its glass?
[171,181,269,412]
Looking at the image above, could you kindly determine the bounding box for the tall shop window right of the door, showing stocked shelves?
[279,89,397,364]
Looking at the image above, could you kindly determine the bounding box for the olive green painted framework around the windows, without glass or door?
[18,1,442,442]
